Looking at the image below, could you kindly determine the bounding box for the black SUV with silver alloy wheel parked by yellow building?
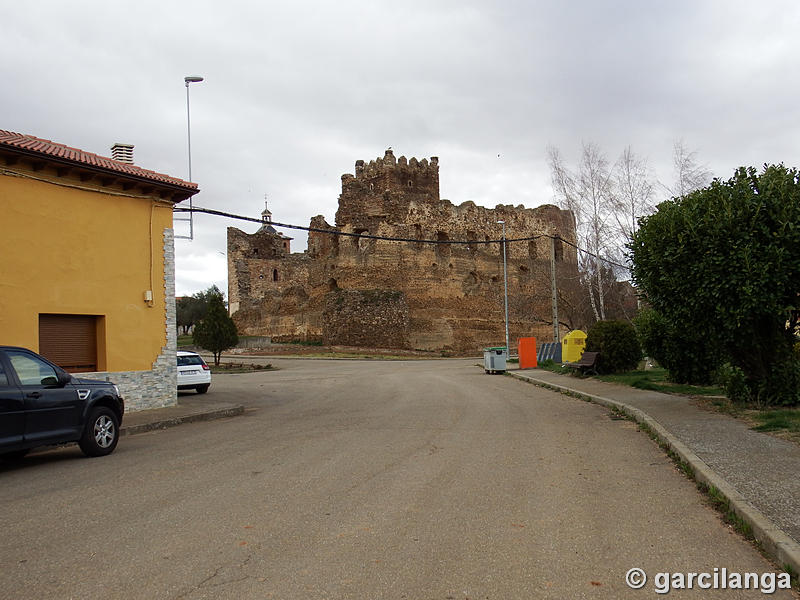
[0,346,125,459]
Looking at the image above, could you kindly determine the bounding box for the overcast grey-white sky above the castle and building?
[0,0,800,295]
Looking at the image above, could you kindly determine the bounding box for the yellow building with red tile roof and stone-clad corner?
[0,130,198,411]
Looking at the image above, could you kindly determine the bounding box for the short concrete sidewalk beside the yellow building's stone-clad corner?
[120,394,244,435]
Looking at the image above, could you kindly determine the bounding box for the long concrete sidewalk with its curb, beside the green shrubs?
[507,369,800,573]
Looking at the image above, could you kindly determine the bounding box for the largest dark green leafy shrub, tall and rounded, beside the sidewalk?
[628,165,800,398]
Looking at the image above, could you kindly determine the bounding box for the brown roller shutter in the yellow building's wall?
[39,315,97,373]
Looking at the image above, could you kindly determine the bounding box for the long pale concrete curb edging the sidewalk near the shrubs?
[506,371,800,574]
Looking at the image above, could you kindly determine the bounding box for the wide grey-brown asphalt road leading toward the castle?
[0,359,794,600]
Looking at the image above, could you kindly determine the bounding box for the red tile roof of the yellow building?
[0,129,198,195]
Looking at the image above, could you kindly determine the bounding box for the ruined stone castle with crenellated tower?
[228,150,577,351]
